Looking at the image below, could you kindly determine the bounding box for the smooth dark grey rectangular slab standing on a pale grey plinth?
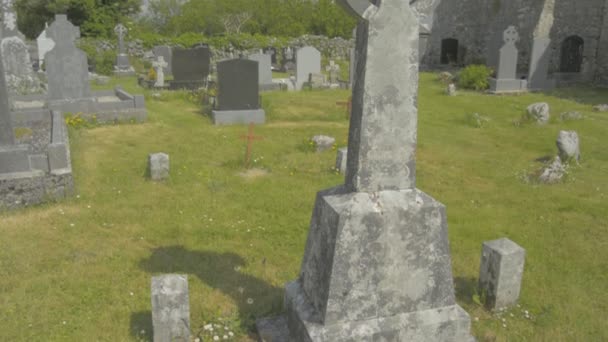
[217,59,260,110]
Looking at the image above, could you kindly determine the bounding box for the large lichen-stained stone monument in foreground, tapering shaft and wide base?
[258,0,473,342]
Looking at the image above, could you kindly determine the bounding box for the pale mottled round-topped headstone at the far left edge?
[0,36,43,95]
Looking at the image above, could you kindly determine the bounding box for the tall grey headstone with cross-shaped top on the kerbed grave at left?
[45,14,91,100]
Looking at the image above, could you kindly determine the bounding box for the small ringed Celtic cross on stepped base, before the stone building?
[489,26,527,93]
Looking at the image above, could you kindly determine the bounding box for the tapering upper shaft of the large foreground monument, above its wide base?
[340,0,418,192]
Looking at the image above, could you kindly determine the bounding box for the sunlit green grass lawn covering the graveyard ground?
[0,73,608,341]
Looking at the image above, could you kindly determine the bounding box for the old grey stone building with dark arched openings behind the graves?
[424,0,608,85]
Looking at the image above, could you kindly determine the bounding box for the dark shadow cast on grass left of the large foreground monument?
[139,246,284,332]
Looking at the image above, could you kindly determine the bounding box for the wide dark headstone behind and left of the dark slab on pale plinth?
[171,46,211,82]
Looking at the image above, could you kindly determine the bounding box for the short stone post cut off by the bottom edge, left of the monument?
[151,274,190,342]
